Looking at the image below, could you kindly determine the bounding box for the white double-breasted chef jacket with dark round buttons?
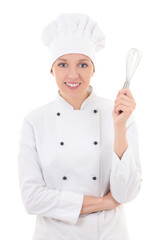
[18,85,141,240]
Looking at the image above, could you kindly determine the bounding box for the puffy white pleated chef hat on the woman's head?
[42,13,105,69]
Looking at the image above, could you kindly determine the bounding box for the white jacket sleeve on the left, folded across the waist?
[18,117,83,224]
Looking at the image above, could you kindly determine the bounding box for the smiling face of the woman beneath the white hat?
[51,53,95,100]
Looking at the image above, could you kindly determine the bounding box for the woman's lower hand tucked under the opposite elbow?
[102,191,120,210]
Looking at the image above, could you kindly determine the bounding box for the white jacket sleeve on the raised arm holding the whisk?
[110,114,142,203]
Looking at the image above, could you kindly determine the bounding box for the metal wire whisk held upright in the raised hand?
[119,48,142,114]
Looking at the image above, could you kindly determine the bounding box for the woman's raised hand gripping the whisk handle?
[112,88,136,125]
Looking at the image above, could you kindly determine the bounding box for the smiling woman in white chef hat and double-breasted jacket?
[18,14,141,240]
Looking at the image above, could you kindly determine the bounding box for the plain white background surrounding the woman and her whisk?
[0,0,160,240]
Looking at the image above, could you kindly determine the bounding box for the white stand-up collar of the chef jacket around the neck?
[56,85,97,111]
